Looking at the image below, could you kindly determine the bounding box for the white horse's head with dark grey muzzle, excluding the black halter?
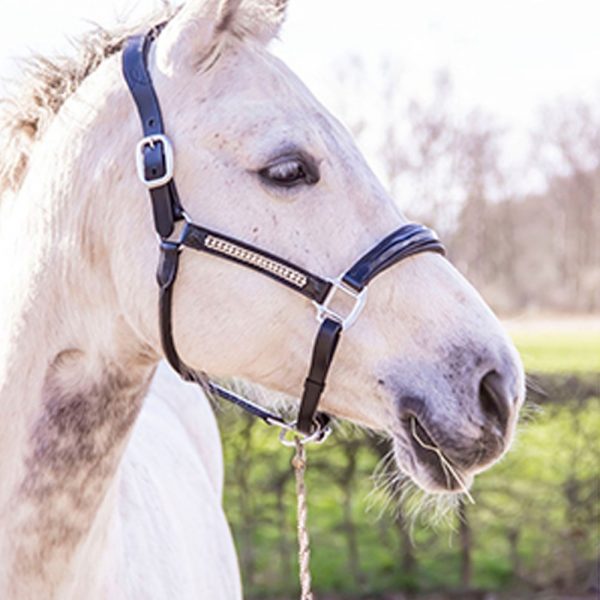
[97,0,524,491]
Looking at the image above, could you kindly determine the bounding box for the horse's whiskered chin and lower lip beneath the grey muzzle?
[393,435,474,495]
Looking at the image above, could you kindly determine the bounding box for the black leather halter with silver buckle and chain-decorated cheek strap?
[123,29,444,439]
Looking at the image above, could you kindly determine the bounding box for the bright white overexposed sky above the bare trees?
[0,0,600,188]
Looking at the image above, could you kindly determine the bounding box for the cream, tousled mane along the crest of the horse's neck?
[0,4,175,198]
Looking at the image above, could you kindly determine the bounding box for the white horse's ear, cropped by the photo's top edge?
[157,0,287,68]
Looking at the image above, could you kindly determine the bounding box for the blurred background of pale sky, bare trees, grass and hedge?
[0,0,600,600]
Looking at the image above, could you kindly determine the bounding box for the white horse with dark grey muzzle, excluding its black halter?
[0,0,524,600]
